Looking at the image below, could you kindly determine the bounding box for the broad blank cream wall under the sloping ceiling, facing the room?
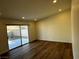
[36,10,71,43]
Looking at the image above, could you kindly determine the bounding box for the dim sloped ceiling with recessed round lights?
[0,0,71,20]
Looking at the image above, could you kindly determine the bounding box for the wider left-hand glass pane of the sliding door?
[7,25,21,49]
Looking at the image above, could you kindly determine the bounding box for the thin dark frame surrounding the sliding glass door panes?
[6,24,30,50]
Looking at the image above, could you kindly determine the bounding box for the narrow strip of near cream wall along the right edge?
[71,0,79,59]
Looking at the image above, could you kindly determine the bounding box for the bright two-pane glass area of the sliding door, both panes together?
[7,25,29,50]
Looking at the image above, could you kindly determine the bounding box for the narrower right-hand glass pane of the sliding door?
[21,25,29,44]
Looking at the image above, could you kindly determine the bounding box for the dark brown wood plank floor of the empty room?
[0,41,73,59]
